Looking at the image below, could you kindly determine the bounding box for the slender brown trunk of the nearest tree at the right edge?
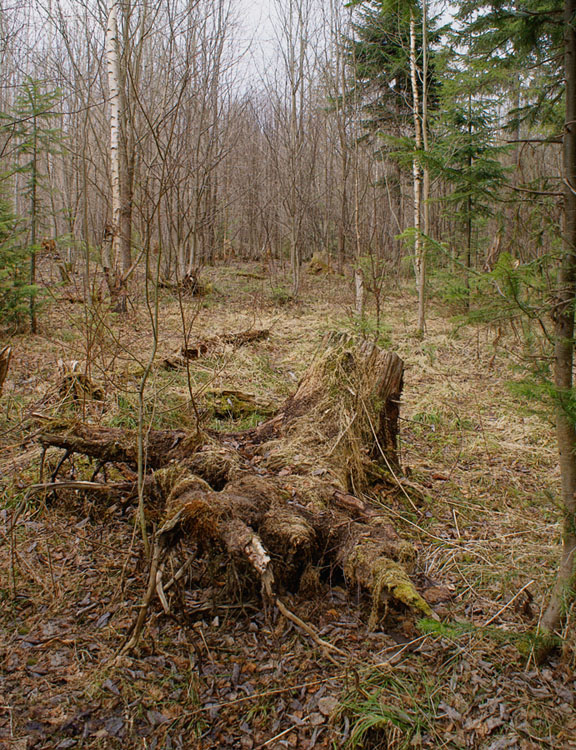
[539,0,576,658]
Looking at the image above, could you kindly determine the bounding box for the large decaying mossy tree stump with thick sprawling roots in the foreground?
[40,340,431,646]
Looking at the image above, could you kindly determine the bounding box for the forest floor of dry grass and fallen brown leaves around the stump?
[0,264,576,750]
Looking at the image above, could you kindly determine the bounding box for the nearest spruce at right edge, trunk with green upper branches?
[459,0,576,658]
